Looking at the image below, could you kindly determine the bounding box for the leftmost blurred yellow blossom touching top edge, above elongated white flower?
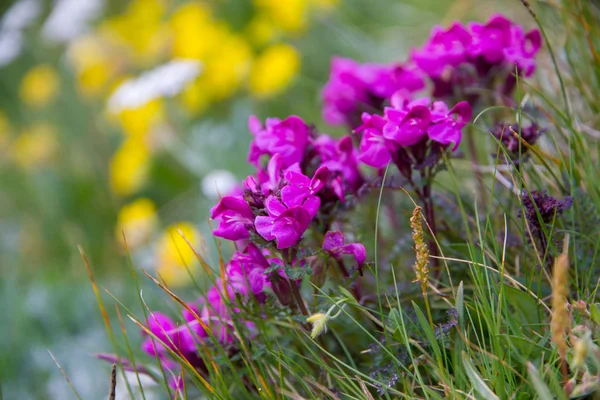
[100,0,169,64]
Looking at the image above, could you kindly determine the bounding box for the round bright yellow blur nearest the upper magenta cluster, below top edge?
[250,44,300,97]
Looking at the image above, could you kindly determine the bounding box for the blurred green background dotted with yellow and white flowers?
[0,0,532,399]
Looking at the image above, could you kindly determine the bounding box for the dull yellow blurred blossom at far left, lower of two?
[12,122,58,168]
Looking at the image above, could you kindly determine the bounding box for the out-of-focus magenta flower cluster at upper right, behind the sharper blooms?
[322,15,542,128]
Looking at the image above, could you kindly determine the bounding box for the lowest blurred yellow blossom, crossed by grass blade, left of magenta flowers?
[156,222,203,286]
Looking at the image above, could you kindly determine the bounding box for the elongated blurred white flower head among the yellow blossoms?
[108,59,202,113]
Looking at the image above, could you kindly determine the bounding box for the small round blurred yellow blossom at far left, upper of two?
[19,64,59,107]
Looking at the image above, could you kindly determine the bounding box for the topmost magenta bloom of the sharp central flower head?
[248,115,309,167]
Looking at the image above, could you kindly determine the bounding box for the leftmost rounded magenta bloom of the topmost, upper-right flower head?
[411,22,472,77]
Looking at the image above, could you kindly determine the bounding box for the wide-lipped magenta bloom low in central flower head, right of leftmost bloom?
[255,206,311,249]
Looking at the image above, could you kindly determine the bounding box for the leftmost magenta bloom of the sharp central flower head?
[210,196,254,240]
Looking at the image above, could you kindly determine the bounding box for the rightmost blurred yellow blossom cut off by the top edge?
[254,0,308,34]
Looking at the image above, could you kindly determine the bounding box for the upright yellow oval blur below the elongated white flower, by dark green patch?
[110,138,151,196]
